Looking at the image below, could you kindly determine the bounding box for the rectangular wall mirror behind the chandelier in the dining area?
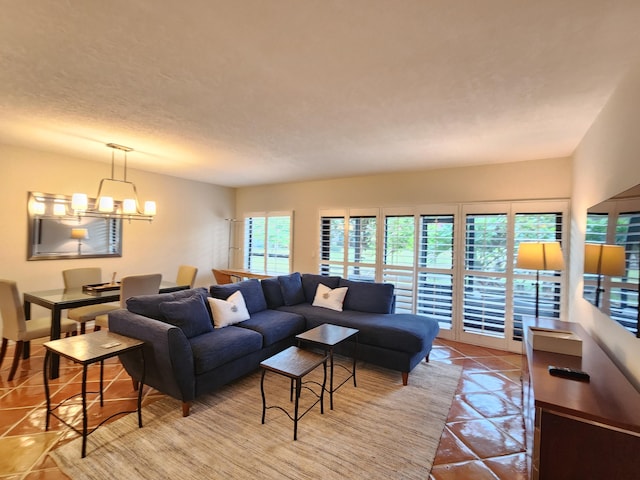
[27,192,122,260]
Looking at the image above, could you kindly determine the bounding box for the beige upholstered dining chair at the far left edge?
[0,280,78,381]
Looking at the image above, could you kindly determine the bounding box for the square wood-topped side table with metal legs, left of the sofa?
[43,331,145,458]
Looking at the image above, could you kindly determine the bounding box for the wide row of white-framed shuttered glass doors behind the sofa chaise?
[320,201,564,351]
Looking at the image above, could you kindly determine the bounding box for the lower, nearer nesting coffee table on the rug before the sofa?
[260,347,327,440]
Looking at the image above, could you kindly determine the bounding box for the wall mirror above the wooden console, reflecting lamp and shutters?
[583,185,640,338]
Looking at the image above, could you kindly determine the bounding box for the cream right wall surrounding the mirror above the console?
[569,67,640,388]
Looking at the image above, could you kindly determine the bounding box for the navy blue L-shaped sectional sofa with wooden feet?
[109,273,439,416]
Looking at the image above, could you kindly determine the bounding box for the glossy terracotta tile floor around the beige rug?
[0,339,528,480]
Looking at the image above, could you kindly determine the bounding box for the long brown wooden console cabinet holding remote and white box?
[523,321,640,480]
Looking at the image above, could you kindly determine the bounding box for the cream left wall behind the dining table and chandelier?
[0,145,235,320]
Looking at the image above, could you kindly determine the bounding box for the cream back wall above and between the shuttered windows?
[236,158,572,272]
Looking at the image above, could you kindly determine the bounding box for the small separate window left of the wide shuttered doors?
[244,212,293,274]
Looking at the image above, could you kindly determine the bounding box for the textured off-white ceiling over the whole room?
[0,0,640,186]
